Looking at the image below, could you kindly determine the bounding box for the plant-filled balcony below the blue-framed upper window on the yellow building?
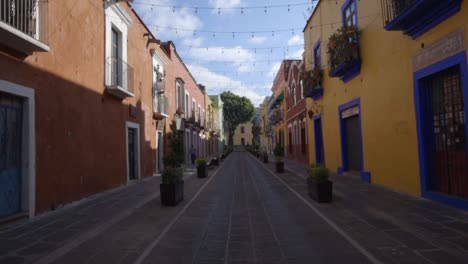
[328,27,361,82]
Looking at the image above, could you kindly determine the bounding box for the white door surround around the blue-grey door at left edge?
[0,80,36,218]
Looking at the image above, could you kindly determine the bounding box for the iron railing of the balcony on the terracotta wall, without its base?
[106,57,134,94]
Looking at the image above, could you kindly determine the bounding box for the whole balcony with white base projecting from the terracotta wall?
[106,57,134,99]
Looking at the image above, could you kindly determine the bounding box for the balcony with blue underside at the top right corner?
[382,0,462,39]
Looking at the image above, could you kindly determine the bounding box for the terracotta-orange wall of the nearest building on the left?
[0,0,165,213]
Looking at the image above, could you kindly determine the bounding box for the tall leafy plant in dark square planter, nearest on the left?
[159,121,184,206]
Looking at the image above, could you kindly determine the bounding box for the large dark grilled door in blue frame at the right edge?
[423,66,468,198]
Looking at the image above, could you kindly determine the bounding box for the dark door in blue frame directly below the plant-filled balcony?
[344,115,362,171]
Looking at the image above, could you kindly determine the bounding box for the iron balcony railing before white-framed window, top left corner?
[0,0,48,44]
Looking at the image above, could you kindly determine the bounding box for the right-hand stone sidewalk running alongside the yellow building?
[267,156,468,263]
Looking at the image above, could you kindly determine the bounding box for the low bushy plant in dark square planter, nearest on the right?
[307,165,333,203]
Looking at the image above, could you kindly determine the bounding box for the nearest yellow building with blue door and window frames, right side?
[304,0,468,208]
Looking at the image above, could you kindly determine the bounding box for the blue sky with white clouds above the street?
[132,0,312,106]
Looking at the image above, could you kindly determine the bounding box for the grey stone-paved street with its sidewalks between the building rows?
[0,152,467,264]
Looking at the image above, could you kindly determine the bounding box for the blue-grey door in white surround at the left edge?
[0,93,22,217]
